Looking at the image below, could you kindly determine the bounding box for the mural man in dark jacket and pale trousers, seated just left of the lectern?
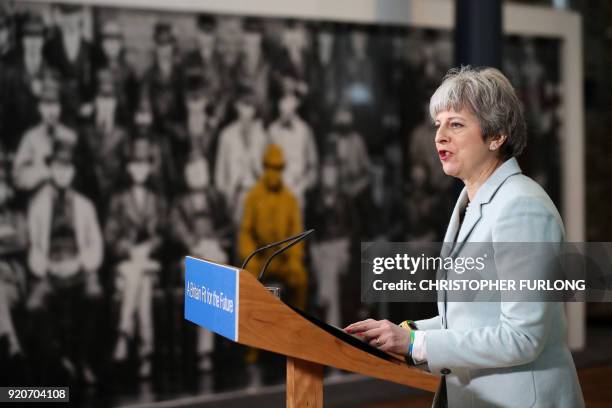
[105,137,166,378]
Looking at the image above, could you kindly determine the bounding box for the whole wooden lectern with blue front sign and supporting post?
[185,257,440,408]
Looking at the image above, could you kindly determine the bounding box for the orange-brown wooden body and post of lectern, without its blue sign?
[184,260,440,408]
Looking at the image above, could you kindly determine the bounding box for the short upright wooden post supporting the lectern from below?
[286,357,323,408]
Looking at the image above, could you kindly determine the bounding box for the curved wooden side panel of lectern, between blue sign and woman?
[238,271,440,392]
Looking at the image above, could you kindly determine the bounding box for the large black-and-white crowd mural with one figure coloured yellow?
[0,1,562,406]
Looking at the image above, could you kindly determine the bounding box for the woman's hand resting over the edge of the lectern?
[344,319,410,354]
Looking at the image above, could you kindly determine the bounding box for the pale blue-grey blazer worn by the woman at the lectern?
[415,158,584,408]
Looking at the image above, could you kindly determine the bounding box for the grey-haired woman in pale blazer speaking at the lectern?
[345,67,584,408]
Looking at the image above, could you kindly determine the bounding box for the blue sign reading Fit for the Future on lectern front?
[185,256,239,341]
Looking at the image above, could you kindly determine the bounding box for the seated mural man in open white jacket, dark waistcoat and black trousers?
[27,140,104,383]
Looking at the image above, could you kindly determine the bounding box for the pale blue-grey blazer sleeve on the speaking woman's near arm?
[417,197,563,374]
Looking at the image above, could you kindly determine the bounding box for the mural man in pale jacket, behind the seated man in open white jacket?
[13,71,77,191]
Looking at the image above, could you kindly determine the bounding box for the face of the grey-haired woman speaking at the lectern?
[434,109,496,180]
